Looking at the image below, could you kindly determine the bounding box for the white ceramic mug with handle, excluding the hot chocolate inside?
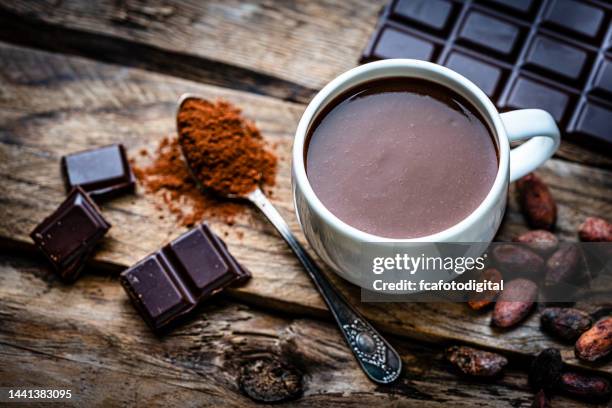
[292,59,559,287]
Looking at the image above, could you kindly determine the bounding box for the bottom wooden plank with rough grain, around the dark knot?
[0,256,596,407]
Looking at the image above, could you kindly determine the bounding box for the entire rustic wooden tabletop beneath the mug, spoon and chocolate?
[0,0,612,406]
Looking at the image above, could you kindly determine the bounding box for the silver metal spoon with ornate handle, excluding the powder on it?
[177,94,402,384]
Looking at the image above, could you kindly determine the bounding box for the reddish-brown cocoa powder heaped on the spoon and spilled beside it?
[132,101,277,227]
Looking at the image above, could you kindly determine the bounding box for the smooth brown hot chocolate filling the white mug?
[306,78,498,238]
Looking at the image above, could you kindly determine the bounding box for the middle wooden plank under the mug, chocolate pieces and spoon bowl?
[0,45,612,372]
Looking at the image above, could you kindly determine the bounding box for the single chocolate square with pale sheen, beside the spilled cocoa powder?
[62,144,135,199]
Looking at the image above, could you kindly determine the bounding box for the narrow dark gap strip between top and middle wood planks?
[0,5,315,102]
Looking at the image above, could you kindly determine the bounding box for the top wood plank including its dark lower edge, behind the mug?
[0,0,612,168]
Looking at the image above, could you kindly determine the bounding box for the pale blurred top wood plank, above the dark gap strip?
[2,0,385,89]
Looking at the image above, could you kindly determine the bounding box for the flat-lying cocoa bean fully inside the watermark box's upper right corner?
[492,244,544,276]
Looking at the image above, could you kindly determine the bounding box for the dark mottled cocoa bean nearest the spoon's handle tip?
[446,346,508,377]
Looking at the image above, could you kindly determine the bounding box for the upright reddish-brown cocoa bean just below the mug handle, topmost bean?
[516,173,557,230]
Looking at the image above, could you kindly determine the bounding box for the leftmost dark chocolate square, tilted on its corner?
[30,187,111,281]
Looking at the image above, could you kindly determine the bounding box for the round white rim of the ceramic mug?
[292,59,510,242]
